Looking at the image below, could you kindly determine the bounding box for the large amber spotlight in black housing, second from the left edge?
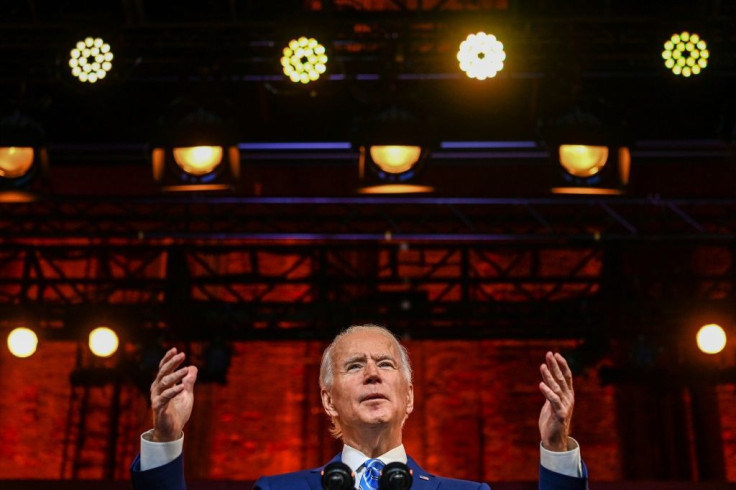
[151,107,240,191]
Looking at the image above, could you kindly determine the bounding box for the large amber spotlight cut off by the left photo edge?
[0,114,48,190]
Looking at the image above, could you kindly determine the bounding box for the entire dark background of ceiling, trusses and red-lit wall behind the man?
[0,0,736,488]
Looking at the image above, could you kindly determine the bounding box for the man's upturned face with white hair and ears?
[322,330,414,436]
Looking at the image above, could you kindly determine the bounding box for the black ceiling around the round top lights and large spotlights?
[0,0,736,196]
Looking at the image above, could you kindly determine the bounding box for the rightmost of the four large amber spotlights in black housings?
[546,109,631,194]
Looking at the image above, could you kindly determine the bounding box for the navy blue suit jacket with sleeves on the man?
[130,454,588,490]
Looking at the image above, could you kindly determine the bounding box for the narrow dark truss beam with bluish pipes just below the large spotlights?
[0,197,736,244]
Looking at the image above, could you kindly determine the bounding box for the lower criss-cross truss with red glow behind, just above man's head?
[0,235,736,341]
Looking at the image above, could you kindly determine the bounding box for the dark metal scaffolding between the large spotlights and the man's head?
[0,198,736,340]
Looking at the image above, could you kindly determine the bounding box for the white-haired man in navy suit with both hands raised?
[131,325,587,490]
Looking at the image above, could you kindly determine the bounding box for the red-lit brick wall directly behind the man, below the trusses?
[0,340,736,482]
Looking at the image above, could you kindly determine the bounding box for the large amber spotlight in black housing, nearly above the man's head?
[356,107,435,193]
